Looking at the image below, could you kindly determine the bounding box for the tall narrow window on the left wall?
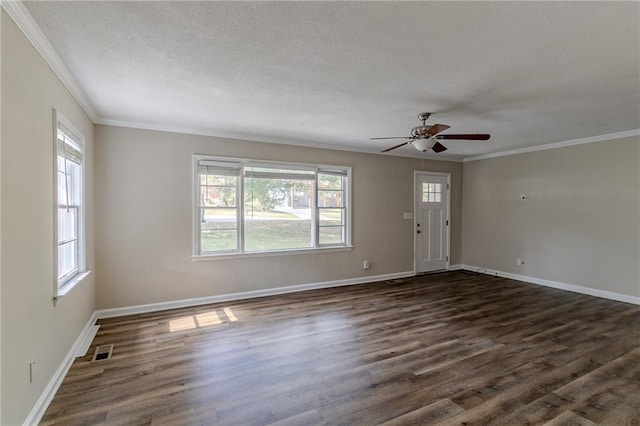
[55,114,84,295]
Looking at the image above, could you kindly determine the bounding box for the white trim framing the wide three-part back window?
[191,154,353,261]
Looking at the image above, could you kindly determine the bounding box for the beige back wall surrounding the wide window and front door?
[95,126,462,308]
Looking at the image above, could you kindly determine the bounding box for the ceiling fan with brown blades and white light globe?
[369,112,491,153]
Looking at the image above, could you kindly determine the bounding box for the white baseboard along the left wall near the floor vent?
[24,312,97,426]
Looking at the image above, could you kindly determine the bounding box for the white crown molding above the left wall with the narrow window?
[0,0,98,122]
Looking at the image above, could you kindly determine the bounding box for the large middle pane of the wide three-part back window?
[244,175,312,251]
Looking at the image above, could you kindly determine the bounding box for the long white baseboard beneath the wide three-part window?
[96,271,415,319]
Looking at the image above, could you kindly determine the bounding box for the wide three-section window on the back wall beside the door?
[194,156,350,256]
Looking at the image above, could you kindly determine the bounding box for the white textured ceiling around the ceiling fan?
[25,1,640,158]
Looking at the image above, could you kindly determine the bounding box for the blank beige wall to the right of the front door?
[462,137,640,297]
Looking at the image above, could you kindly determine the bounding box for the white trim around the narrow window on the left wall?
[53,108,90,304]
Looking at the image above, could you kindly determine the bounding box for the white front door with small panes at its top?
[414,172,449,273]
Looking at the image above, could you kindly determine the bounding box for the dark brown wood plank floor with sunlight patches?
[42,272,640,425]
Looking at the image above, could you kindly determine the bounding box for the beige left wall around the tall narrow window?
[0,11,95,425]
